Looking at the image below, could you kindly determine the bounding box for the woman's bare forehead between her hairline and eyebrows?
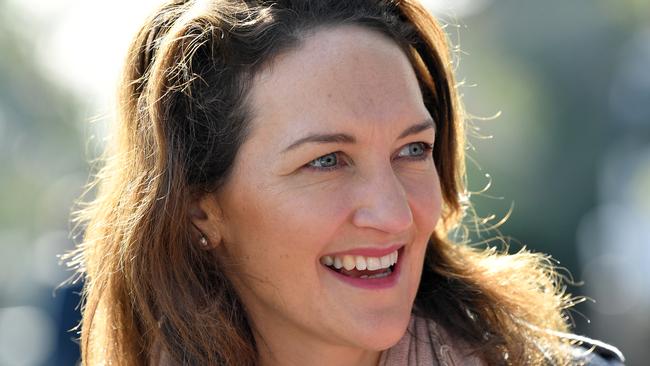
[243,25,428,146]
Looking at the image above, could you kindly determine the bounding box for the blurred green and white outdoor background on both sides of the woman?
[0,0,650,366]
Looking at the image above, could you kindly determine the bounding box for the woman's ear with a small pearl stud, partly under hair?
[189,194,223,249]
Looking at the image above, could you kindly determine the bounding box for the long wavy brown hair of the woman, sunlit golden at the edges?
[67,0,572,365]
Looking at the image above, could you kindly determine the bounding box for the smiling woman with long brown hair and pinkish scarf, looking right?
[66,0,624,365]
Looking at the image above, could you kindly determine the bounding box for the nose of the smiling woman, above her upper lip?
[352,168,413,234]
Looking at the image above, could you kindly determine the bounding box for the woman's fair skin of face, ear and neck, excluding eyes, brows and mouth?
[193,26,441,365]
